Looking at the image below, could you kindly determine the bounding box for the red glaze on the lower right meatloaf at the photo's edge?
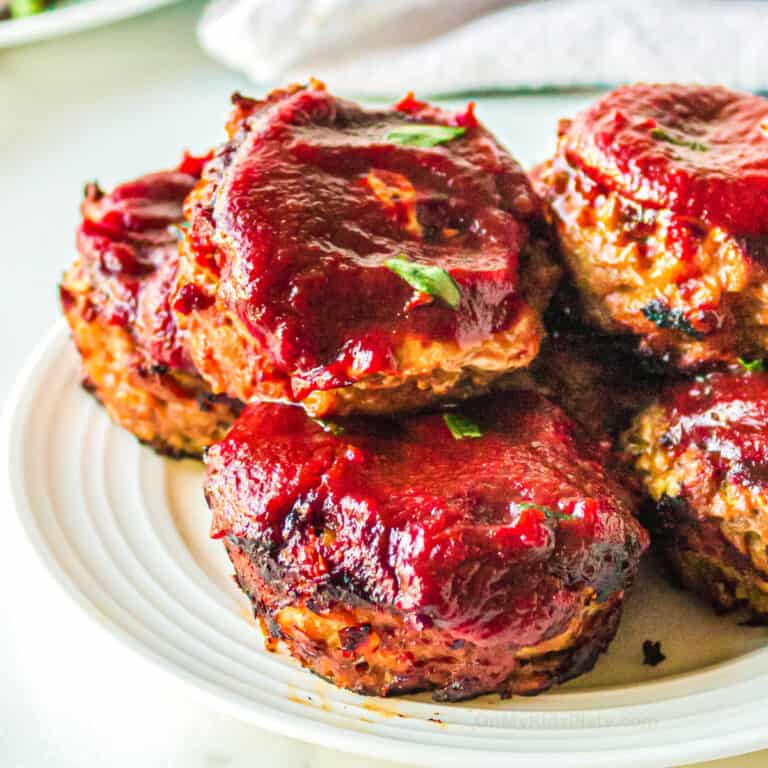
[661,373,768,487]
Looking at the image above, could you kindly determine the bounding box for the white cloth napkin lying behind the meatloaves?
[199,0,768,97]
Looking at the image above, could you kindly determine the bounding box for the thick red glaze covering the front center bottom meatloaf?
[206,393,647,646]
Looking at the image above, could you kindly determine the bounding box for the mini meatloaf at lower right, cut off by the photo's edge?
[625,372,768,616]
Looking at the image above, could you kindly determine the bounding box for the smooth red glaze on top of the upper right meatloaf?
[562,83,768,235]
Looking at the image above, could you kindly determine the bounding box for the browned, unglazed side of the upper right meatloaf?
[537,158,768,368]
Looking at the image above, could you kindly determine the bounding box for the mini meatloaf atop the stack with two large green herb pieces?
[173,83,559,415]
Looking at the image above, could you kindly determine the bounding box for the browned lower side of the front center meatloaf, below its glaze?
[225,539,623,701]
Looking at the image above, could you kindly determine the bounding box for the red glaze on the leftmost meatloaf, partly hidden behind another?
[71,160,205,370]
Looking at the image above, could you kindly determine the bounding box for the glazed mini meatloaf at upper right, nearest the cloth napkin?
[535,84,768,369]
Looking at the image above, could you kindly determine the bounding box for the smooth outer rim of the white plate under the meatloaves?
[0,319,768,768]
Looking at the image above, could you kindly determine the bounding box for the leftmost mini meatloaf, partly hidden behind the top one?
[60,157,239,456]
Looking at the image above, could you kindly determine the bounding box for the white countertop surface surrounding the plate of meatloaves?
[0,0,768,768]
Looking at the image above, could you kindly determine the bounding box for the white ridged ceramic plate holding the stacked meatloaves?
[6,325,768,768]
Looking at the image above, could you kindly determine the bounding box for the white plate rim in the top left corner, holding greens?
[0,0,178,48]
